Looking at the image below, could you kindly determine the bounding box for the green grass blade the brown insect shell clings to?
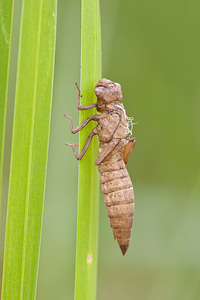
[75,0,101,300]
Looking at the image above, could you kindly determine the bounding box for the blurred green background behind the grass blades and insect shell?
[1,0,200,300]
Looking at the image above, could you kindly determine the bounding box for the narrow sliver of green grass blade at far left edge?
[0,0,13,206]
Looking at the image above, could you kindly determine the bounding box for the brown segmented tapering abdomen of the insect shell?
[98,152,134,255]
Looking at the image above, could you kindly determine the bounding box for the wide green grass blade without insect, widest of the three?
[2,0,57,300]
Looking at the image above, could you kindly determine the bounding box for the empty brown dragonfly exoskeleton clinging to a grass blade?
[65,78,135,255]
